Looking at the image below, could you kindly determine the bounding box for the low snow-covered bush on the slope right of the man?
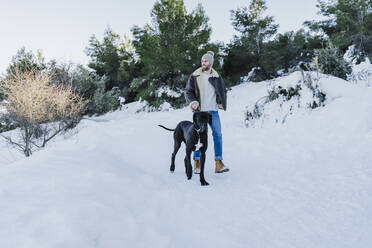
[245,71,326,127]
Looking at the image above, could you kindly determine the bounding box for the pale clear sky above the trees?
[0,0,321,75]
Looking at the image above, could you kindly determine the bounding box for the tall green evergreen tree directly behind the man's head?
[131,0,219,107]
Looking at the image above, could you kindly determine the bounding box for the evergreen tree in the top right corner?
[305,0,372,62]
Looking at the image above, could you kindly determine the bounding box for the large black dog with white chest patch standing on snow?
[159,111,212,185]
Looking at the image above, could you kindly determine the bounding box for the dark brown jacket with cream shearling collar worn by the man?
[185,68,227,110]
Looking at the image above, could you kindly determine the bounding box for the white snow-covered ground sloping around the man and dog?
[0,71,372,248]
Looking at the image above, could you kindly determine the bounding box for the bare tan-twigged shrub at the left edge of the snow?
[1,70,86,157]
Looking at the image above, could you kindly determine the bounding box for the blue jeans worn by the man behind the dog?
[194,111,222,160]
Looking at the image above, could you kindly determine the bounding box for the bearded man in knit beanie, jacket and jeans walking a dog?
[185,51,229,174]
